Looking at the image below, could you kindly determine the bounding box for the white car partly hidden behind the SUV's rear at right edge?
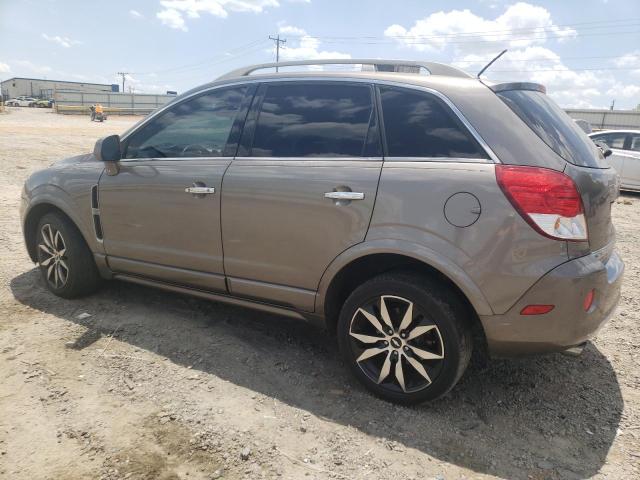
[589,130,640,192]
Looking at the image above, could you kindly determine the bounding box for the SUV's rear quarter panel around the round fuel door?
[366,161,568,313]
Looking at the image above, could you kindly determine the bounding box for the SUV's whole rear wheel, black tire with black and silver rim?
[337,273,472,405]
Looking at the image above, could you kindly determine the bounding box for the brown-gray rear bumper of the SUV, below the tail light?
[480,251,624,357]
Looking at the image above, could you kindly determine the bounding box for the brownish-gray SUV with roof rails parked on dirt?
[21,60,624,404]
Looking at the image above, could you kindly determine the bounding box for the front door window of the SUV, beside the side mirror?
[125,87,246,158]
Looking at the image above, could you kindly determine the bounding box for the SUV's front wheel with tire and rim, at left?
[35,212,101,298]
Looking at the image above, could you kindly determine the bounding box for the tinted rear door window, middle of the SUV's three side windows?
[251,84,379,157]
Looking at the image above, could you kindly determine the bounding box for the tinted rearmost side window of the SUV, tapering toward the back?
[380,87,487,158]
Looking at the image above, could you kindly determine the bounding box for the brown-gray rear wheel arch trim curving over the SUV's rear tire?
[315,240,493,335]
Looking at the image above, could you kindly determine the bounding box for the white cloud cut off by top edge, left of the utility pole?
[156,0,280,31]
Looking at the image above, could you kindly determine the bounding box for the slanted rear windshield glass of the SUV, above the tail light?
[497,90,608,168]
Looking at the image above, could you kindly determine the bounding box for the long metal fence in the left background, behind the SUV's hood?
[54,90,175,115]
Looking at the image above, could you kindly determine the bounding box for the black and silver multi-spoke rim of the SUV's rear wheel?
[349,295,445,393]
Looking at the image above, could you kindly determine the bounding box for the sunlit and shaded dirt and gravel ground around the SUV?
[0,108,640,480]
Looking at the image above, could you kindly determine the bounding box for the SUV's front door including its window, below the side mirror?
[98,86,252,291]
